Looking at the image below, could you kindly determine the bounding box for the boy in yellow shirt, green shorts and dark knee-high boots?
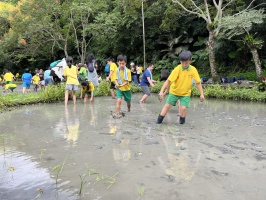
[156,51,204,124]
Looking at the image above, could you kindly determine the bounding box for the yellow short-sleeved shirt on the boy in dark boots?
[168,65,200,96]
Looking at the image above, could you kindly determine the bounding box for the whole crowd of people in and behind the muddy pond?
[1,51,204,124]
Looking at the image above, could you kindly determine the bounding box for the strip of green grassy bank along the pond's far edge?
[0,81,266,110]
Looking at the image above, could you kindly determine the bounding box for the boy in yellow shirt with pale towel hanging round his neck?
[115,55,131,118]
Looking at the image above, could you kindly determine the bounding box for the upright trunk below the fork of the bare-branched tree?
[207,28,218,83]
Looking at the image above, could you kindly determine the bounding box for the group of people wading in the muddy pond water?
[64,51,204,124]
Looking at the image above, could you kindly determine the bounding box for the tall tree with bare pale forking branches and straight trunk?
[173,0,255,82]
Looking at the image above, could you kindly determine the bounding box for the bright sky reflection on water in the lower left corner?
[0,147,76,200]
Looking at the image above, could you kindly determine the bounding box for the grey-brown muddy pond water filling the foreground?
[0,94,266,200]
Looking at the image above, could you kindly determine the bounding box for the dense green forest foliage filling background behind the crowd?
[0,0,266,79]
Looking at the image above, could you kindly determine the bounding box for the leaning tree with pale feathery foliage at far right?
[220,9,266,81]
